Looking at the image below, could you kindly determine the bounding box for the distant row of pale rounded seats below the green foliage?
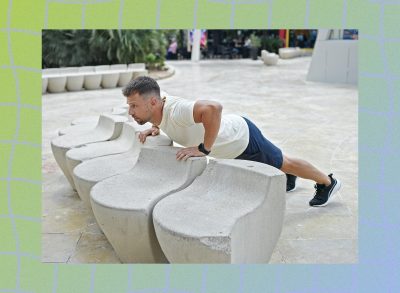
[42,63,148,94]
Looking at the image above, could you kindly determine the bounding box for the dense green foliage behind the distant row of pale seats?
[42,30,176,68]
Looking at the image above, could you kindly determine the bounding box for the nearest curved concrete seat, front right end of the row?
[153,160,286,263]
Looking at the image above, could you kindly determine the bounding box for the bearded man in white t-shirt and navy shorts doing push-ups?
[123,77,340,206]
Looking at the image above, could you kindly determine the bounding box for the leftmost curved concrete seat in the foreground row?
[51,114,127,189]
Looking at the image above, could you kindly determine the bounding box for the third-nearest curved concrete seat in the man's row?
[72,135,172,205]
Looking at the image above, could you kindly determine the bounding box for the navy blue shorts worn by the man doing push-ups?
[235,117,283,169]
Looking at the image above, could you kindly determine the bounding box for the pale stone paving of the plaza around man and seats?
[42,57,358,263]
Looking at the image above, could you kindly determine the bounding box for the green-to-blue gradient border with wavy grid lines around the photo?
[0,0,400,293]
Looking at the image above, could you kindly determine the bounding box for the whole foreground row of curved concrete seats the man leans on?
[51,107,285,263]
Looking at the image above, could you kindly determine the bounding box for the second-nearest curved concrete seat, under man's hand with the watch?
[90,147,206,263]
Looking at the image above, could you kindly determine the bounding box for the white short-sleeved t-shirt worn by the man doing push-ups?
[159,96,249,159]
